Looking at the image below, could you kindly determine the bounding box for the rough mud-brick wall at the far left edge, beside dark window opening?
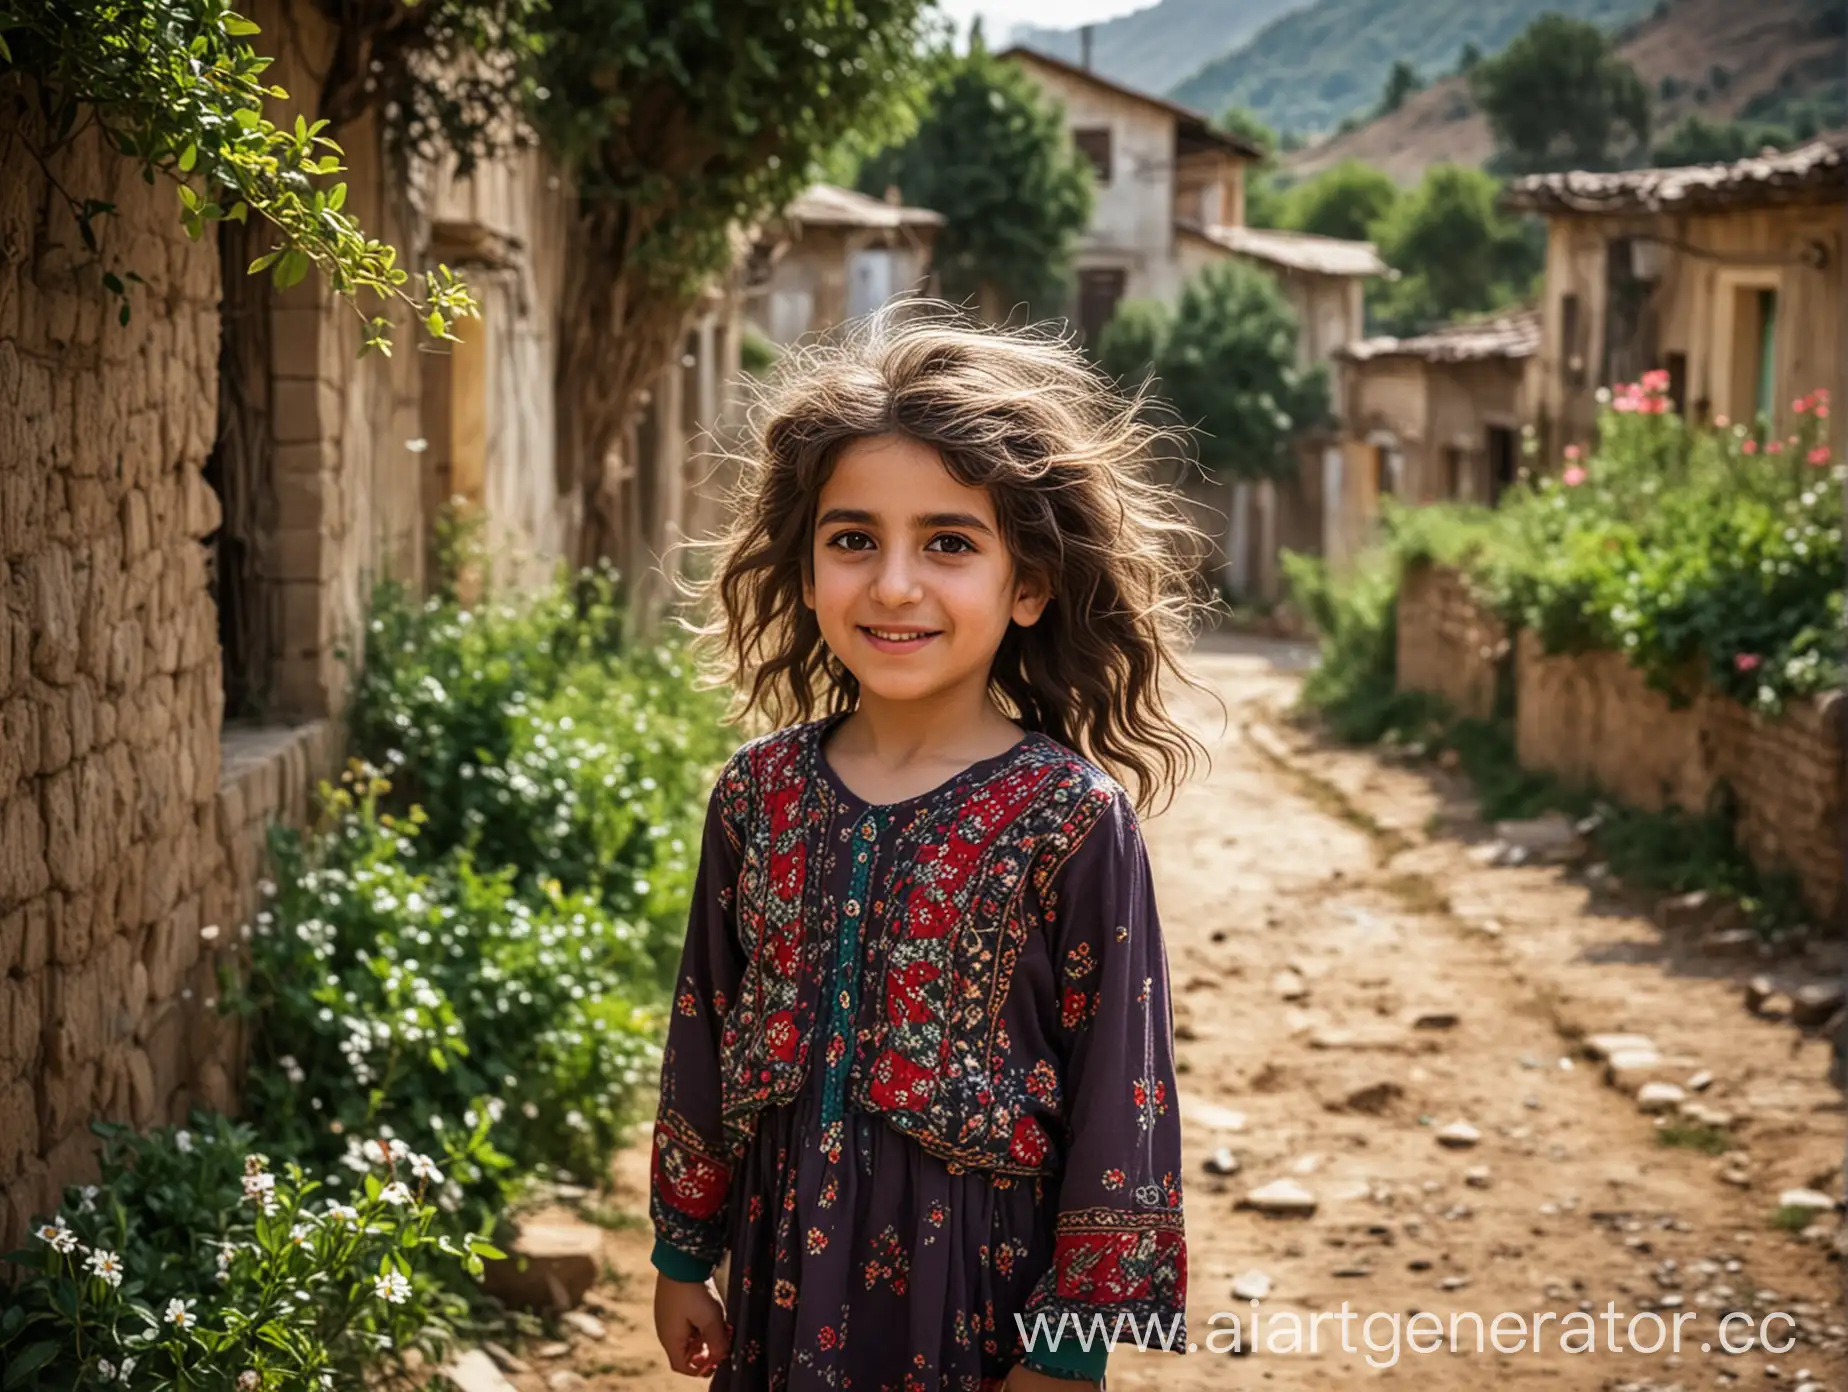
[0,116,331,1250]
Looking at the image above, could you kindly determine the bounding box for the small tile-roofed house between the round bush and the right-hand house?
[1323,309,1539,562]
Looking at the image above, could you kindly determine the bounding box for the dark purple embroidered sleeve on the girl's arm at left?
[649,767,745,1281]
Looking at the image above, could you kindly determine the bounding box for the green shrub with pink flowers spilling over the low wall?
[1392,373,1848,710]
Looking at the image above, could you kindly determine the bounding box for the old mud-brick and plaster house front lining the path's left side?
[0,0,737,1250]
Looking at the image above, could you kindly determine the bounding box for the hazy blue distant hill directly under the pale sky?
[1009,0,1312,101]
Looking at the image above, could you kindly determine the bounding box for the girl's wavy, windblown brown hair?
[691,299,1209,806]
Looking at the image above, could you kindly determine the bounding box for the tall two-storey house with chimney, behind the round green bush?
[1002,48,1386,597]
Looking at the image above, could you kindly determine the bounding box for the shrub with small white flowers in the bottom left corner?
[0,1115,501,1392]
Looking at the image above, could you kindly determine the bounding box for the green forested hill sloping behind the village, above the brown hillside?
[1170,0,1663,133]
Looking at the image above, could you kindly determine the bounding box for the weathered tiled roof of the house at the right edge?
[1502,131,1848,213]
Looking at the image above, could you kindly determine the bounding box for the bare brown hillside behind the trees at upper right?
[1283,0,1848,183]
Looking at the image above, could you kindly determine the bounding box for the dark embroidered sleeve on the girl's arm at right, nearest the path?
[1022,793,1186,1379]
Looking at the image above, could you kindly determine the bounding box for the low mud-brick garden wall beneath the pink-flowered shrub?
[1399,566,1848,922]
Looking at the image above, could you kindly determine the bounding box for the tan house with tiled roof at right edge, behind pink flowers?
[1504,133,1848,457]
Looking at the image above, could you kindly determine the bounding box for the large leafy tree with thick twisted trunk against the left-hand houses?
[529,0,928,556]
